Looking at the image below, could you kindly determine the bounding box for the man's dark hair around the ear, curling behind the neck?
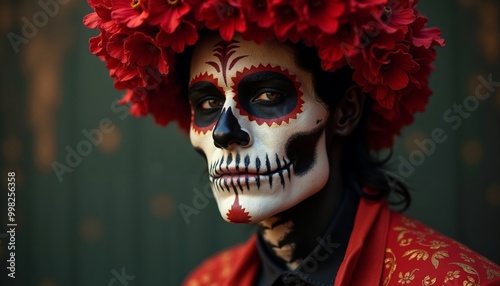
[293,43,411,211]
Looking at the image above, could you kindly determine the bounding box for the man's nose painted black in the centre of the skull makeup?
[212,107,250,149]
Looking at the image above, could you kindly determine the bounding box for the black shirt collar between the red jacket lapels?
[257,189,359,286]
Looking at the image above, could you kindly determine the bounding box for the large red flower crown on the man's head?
[84,0,444,150]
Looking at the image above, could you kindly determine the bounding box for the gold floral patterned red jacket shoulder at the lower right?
[382,213,500,286]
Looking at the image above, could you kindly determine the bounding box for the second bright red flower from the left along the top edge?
[148,0,190,34]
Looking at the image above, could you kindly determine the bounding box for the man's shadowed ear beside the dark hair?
[332,86,365,137]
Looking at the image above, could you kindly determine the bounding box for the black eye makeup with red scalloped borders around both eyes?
[188,65,304,133]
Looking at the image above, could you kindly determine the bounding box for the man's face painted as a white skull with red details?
[189,36,329,223]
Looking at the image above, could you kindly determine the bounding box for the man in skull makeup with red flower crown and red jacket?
[85,0,500,285]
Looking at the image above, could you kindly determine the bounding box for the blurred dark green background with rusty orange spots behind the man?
[0,0,500,286]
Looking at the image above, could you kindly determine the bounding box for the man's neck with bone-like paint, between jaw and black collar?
[258,142,343,270]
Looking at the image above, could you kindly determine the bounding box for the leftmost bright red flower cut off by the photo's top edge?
[111,0,149,28]
